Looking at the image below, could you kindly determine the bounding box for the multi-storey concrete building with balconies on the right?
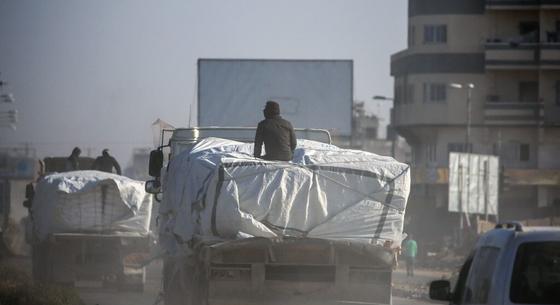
[391,0,560,243]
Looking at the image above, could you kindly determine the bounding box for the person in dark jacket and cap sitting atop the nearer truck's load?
[253,101,297,161]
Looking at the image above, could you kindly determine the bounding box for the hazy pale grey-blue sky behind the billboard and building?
[0,0,407,166]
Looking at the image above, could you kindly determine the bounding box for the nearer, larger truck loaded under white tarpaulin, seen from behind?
[145,127,410,305]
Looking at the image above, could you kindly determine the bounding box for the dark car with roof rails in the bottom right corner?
[430,223,560,305]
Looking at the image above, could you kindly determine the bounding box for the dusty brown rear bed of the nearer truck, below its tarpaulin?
[164,238,393,305]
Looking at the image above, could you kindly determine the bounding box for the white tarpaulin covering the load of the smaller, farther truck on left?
[32,171,152,240]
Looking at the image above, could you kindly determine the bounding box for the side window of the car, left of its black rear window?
[465,247,500,304]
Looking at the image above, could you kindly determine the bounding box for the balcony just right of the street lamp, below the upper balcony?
[484,101,544,125]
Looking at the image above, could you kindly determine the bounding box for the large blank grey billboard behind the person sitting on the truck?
[198,59,353,135]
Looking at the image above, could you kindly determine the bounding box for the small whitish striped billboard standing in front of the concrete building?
[449,152,500,215]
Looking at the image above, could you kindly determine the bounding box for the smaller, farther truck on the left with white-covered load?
[25,158,152,291]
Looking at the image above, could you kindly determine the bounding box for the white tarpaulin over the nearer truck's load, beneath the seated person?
[160,138,410,252]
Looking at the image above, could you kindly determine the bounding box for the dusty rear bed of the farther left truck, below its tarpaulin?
[33,233,149,289]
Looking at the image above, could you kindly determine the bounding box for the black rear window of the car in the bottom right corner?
[509,241,560,304]
